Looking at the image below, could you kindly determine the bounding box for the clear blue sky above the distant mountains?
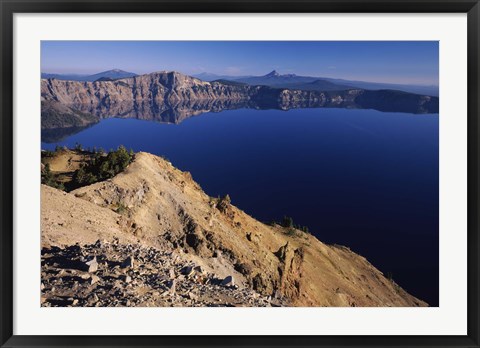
[41,41,438,85]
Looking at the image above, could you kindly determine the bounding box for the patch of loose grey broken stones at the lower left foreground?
[40,242,287,307]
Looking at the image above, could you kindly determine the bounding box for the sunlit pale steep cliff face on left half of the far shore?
[41,72,248,115]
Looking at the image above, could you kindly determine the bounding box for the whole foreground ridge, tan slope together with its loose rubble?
[41,153,426,306]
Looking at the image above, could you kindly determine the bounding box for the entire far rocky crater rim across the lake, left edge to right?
[41,71,438,129]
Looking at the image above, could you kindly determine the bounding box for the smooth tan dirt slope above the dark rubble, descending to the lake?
[42,153,427,306]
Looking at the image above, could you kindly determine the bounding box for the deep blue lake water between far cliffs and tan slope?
[42,108,439,306]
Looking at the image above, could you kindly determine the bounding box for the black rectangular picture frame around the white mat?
[0,0,480,347]
